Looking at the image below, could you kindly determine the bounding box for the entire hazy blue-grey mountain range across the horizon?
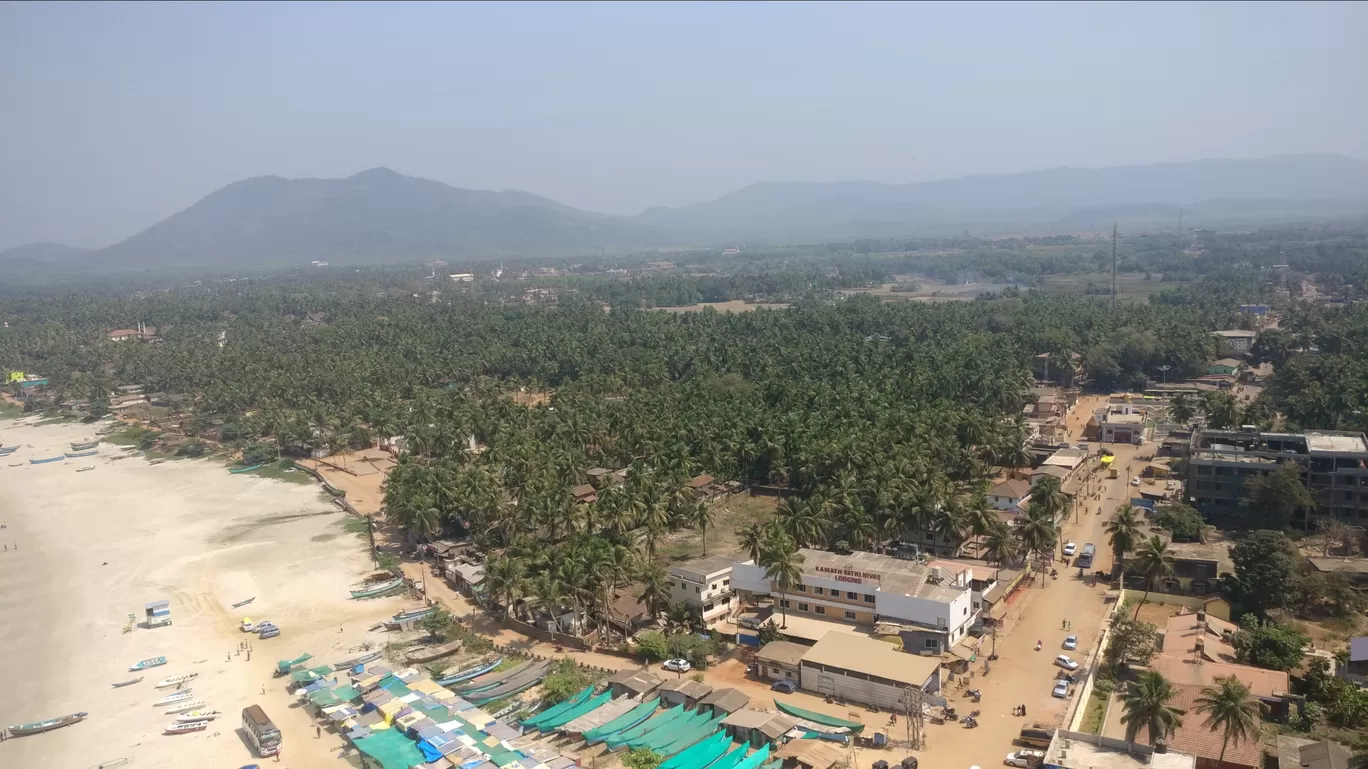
[0,155,1368,270]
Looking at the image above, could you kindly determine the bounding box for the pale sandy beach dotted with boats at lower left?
[0,420,412,769]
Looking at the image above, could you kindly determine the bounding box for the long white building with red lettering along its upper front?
[732,547,986,654]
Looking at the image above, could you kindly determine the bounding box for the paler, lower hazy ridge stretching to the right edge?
[639,149,1368,233]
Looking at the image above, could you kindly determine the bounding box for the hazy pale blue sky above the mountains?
[0,3,1368,248]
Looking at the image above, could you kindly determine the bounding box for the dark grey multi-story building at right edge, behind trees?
[1187,427,1368,525]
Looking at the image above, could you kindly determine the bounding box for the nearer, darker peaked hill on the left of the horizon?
[94,168,666,268]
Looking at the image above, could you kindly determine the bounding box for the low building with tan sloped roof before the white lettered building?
[800,631,940,709]
